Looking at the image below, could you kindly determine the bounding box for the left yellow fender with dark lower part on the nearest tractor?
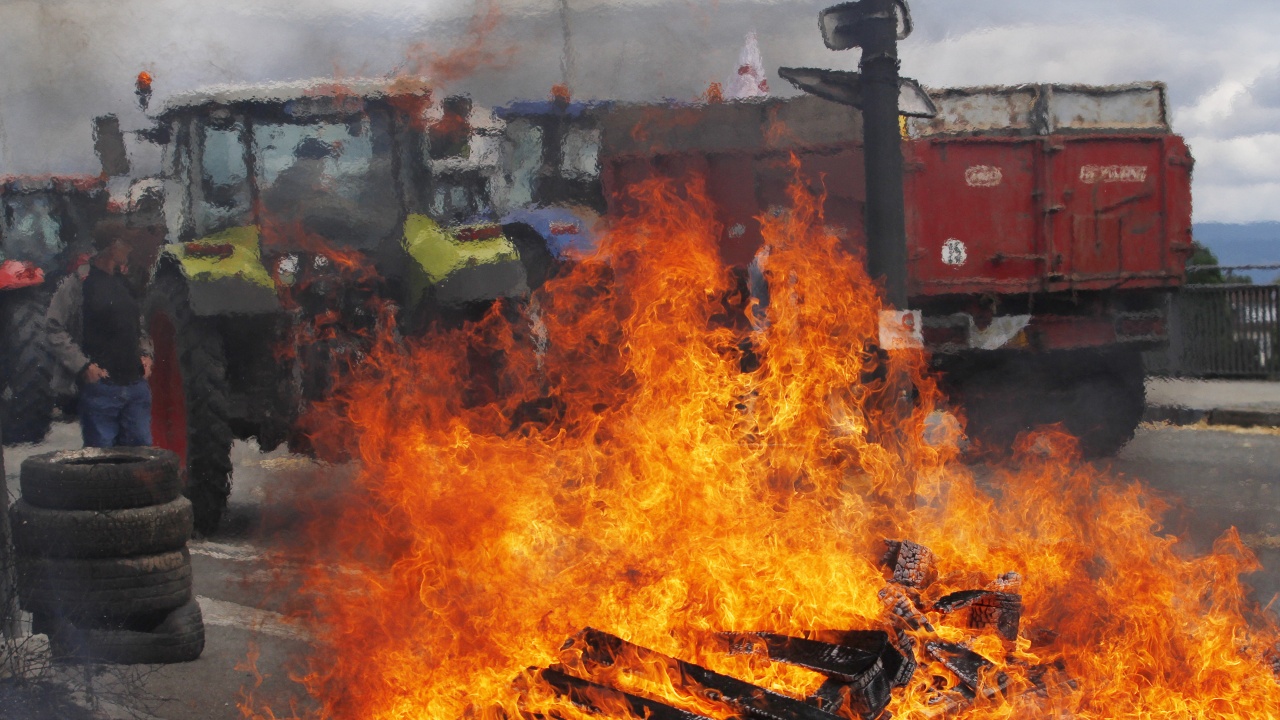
[156,225,282,315]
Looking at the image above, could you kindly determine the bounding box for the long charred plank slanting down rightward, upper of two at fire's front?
[573,628,835,720]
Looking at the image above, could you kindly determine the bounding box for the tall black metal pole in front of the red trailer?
[859,0,906,304]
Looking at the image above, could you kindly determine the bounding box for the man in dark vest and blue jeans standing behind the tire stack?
[49,224,151,447]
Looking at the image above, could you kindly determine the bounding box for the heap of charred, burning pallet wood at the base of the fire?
[526,541,1074,720]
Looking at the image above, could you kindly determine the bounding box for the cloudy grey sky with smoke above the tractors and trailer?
[0,0,1280,222]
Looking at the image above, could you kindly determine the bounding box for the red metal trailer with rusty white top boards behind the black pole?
[584,83,1192,455]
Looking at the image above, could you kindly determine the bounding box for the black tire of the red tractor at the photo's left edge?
[0,287,54,445]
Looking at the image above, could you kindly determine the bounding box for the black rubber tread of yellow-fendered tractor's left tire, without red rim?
[146,272,234,536]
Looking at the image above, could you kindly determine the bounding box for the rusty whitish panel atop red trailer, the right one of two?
[1044,82,1169,133]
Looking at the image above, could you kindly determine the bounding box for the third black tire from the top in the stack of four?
[18,548,192,625]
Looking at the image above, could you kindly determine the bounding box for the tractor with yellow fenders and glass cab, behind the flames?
[146,78,554,534]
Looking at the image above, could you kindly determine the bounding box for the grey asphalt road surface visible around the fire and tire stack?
[0,417,1280,720]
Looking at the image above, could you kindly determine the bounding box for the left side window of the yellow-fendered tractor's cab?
[198,123,250,234]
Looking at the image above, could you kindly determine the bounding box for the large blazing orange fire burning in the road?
[244,165,1280,720]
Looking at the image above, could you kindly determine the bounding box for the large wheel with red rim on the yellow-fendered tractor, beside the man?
[146,272,234,536]
